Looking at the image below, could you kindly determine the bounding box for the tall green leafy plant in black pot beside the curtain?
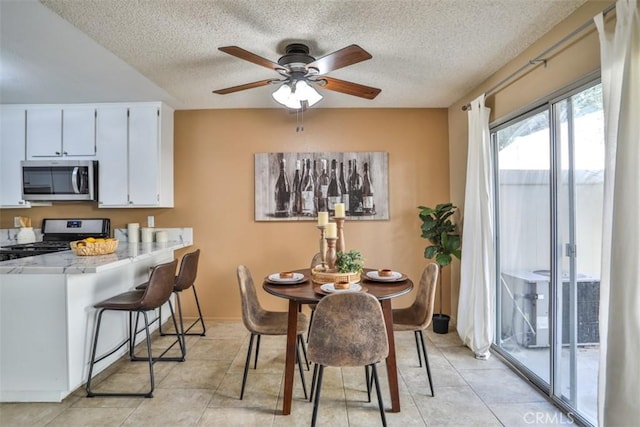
[418,203,462,334]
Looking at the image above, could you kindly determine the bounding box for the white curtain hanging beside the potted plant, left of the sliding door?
[457,94,495,359]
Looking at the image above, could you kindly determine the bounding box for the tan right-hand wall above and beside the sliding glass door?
[449,1,614,320]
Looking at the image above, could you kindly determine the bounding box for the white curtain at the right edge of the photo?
[594,0,640,427]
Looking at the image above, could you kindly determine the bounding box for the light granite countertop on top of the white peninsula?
[0,240,191,274]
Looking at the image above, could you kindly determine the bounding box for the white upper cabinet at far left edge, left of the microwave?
[0,106,30,208]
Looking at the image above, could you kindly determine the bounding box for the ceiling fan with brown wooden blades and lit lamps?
[213,43,381,109]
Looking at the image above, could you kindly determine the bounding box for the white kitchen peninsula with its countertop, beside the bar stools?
[0,228,193,402]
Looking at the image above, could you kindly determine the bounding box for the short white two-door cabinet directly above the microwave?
[27,105,96,160]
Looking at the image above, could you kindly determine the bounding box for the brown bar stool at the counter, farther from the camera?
[136,249,207,357]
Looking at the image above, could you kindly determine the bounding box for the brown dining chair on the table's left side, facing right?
[237,265,309,400]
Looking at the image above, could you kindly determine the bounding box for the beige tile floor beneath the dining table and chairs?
[0,321,570,427]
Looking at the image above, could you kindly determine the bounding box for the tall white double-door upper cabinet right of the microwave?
[96,103,173,208]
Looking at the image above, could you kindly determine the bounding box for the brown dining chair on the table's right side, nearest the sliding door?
[393,263,438,396]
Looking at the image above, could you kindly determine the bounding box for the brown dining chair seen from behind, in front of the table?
[307,292,389,426]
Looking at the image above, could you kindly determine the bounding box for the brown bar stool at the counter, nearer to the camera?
[86,260,184,397]
